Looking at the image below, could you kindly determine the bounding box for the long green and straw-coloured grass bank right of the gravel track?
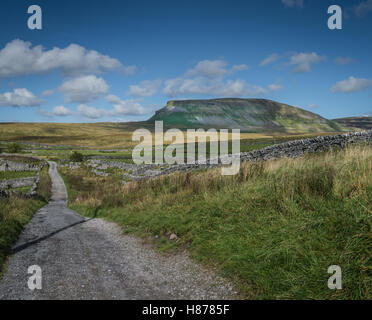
[61,146,372,299]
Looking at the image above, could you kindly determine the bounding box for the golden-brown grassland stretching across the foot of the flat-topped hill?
[0,122,346,163]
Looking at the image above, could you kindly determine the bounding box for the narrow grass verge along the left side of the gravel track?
[0,167,51,277]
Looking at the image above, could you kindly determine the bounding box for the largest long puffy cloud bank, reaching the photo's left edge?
[0,39,125,78]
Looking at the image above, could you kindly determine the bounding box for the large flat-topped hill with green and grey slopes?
[149,98,346,133]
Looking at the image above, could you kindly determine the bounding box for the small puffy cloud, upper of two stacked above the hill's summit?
[185,60,248,78]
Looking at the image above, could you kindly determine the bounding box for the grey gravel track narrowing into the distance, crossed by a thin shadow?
[0,162,233,299]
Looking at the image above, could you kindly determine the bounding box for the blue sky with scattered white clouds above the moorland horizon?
[0,0,372,122]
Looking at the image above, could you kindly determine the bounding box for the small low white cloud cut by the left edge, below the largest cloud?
[0,88,43,107]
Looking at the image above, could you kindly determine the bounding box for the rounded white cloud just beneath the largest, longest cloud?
[58,75,109,103]
